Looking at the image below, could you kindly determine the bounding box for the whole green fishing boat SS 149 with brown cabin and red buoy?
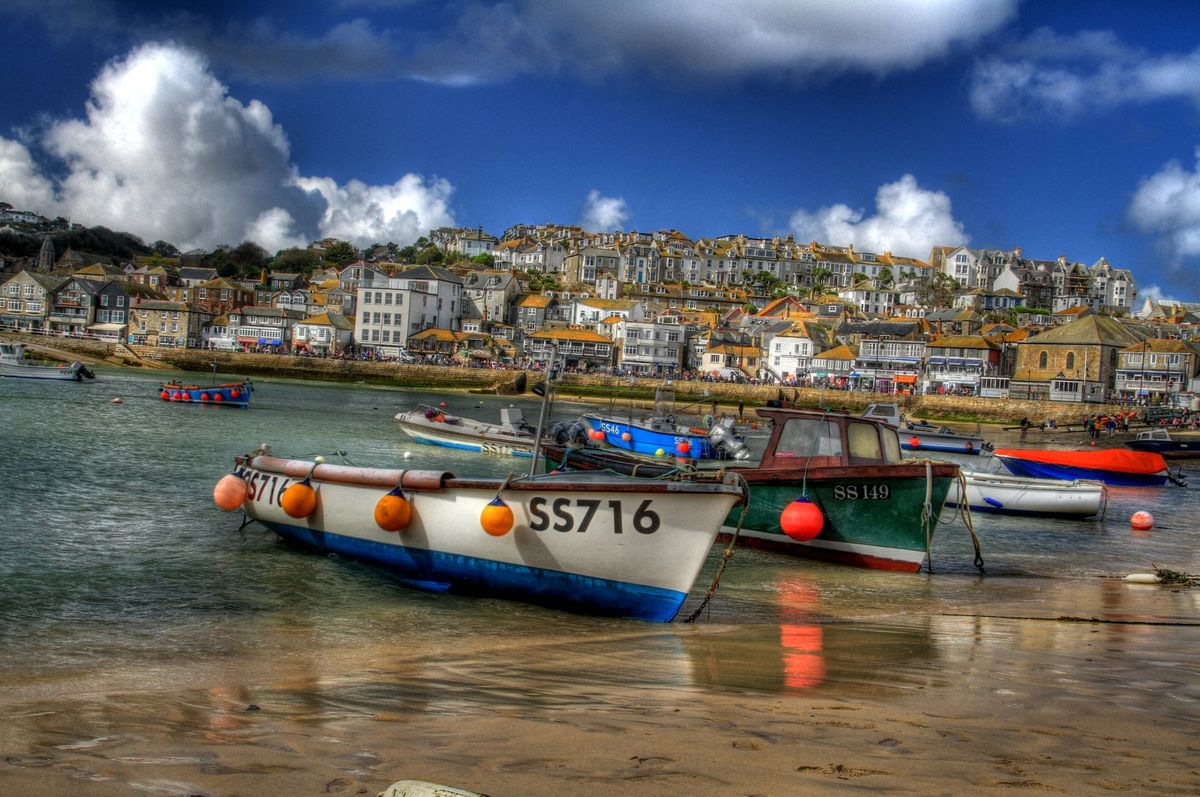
[544,408,959,571]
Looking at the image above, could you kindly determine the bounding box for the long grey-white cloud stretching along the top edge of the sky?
[410,0,1018,84]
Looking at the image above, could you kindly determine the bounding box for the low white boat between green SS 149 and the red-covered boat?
[946,471,1105,517]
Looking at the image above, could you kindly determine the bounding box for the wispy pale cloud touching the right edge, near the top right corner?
[971,29,1200,121]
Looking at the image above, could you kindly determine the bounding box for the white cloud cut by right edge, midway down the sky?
[1128,148,1200,264]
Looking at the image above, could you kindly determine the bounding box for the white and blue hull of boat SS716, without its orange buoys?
[231,456,742,622]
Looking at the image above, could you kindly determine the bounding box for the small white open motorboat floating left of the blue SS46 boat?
[394,406,536,456]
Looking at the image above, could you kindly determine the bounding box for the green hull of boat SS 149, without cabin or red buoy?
[546,444,958,573]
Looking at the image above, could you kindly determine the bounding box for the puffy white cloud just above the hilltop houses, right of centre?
[790,174,971,258]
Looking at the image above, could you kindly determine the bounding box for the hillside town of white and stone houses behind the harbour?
[0,203,1200,406]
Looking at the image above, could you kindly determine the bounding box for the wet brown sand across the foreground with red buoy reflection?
[0,579,1200,797]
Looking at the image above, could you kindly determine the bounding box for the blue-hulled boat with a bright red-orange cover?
[995,449,1171,487]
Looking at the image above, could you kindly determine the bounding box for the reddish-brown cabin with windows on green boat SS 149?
[756,408,904,468]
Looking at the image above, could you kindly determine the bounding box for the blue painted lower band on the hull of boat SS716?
[263,521,688,623]
